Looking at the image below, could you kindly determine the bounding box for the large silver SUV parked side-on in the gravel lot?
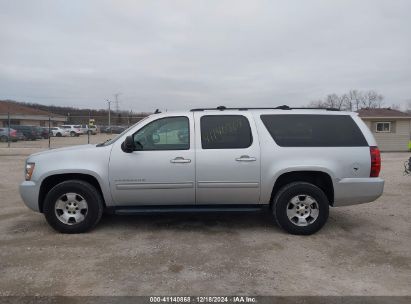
[20,106,384,234]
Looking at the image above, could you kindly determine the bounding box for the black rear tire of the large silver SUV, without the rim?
[272,182,329,235]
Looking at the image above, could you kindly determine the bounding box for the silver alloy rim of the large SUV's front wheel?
[54,193,88,225]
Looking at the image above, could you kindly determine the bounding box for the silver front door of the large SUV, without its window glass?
[109,113,195,206]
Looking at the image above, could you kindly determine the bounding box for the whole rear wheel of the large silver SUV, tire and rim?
[272,182,329,235]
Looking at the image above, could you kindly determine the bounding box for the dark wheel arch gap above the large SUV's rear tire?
[270,170,334,206]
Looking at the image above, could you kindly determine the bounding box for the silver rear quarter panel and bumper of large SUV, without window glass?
[254,110,384,206]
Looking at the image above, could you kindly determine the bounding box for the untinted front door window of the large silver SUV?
[133,116,190,151]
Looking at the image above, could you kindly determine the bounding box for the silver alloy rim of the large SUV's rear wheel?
[287,194,319,226]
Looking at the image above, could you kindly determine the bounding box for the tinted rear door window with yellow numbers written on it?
[201,115,253,149]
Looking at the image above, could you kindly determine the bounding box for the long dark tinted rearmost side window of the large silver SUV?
[261,114,368,147]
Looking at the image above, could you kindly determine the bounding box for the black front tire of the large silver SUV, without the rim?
[43,180,104,233]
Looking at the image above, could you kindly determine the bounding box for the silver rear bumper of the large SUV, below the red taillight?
[333,177,384,207]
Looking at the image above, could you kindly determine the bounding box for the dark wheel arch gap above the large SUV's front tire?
[38,173,106,212]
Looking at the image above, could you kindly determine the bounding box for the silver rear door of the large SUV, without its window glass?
[195,111,260,205]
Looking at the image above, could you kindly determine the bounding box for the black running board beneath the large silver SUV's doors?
[113,205,268,215]
